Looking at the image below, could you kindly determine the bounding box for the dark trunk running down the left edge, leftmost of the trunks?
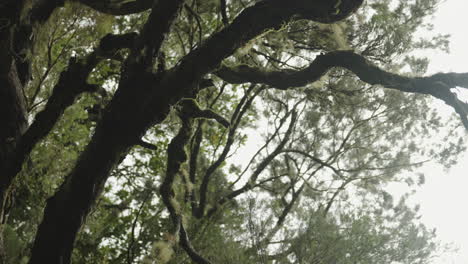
[0,0,64,254]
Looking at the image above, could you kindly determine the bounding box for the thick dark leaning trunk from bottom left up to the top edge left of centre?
[30,0,183,264]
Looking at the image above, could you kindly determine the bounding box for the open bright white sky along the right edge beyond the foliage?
[415,0,468,264]
